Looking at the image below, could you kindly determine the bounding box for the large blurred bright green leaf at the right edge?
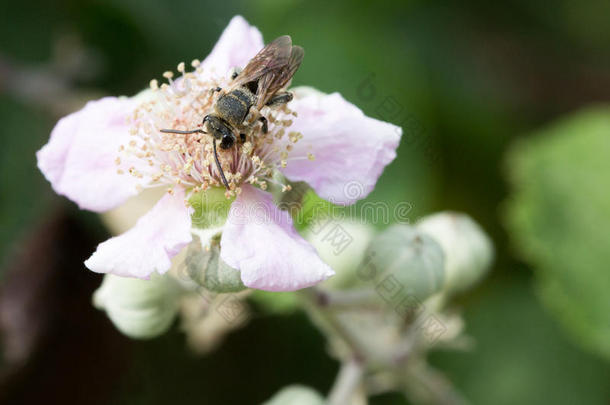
[507,108,610,359]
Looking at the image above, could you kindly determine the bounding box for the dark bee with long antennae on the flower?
[161,35,305,190]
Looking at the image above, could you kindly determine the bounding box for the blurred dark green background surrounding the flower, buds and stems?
[0,0,610,405]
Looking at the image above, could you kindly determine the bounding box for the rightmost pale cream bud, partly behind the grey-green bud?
[417,212,494,292]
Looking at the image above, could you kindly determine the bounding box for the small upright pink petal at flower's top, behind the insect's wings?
[201,15,265,77]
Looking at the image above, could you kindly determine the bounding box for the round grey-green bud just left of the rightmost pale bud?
[357,224,445,302]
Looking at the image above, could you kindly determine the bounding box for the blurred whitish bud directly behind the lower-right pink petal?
[304,219,375,287]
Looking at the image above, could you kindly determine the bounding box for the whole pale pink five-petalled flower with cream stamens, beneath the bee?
[37,16,401,291]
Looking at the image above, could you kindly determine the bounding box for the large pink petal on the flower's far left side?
[36,97,148,212]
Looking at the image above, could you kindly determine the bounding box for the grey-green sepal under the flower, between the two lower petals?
[184,237,246,293]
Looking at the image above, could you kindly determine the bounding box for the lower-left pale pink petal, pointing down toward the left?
[85,188,192,279]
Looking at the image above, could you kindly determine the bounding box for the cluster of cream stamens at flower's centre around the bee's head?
[117,60,311,197]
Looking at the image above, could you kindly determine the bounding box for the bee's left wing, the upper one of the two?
[231,35,292,87]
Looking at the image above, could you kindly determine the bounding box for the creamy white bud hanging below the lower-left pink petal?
[93,274,181,339]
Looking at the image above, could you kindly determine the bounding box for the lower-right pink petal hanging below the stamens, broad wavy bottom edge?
[220,185,334,291]
